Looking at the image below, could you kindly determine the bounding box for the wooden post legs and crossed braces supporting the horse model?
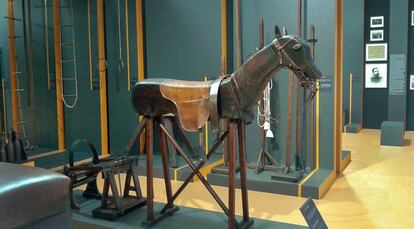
[137,117,253,228]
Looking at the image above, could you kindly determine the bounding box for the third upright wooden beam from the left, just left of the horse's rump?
[96,0,109,156]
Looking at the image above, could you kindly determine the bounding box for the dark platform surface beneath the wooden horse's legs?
[72,200,307,229]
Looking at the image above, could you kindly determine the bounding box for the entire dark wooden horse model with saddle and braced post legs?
[131,29,322,228]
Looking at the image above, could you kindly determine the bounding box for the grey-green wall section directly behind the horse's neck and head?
[236,0,297,165]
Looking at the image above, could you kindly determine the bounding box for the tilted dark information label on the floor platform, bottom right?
[300,198,328,229]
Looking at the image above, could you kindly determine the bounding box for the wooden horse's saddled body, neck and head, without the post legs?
[132,32,321,131]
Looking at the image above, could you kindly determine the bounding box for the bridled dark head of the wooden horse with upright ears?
[273,26,322,90]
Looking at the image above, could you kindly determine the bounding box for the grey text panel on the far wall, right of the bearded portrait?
[389,54,407,95]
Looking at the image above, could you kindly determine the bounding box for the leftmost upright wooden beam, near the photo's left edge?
[7,1,20,134]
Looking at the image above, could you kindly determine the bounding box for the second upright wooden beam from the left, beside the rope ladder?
[53,0,65,150]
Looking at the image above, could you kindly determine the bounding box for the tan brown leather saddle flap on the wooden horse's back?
[160,80,213,131]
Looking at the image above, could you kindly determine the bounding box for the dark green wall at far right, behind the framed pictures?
[364,0,414,130]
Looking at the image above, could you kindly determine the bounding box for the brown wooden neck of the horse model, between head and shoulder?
[231,44,282,111]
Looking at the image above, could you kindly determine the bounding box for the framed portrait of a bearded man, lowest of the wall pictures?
[365,64,388,88]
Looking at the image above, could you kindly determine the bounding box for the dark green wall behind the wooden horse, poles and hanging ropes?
[0,0,340,168]
